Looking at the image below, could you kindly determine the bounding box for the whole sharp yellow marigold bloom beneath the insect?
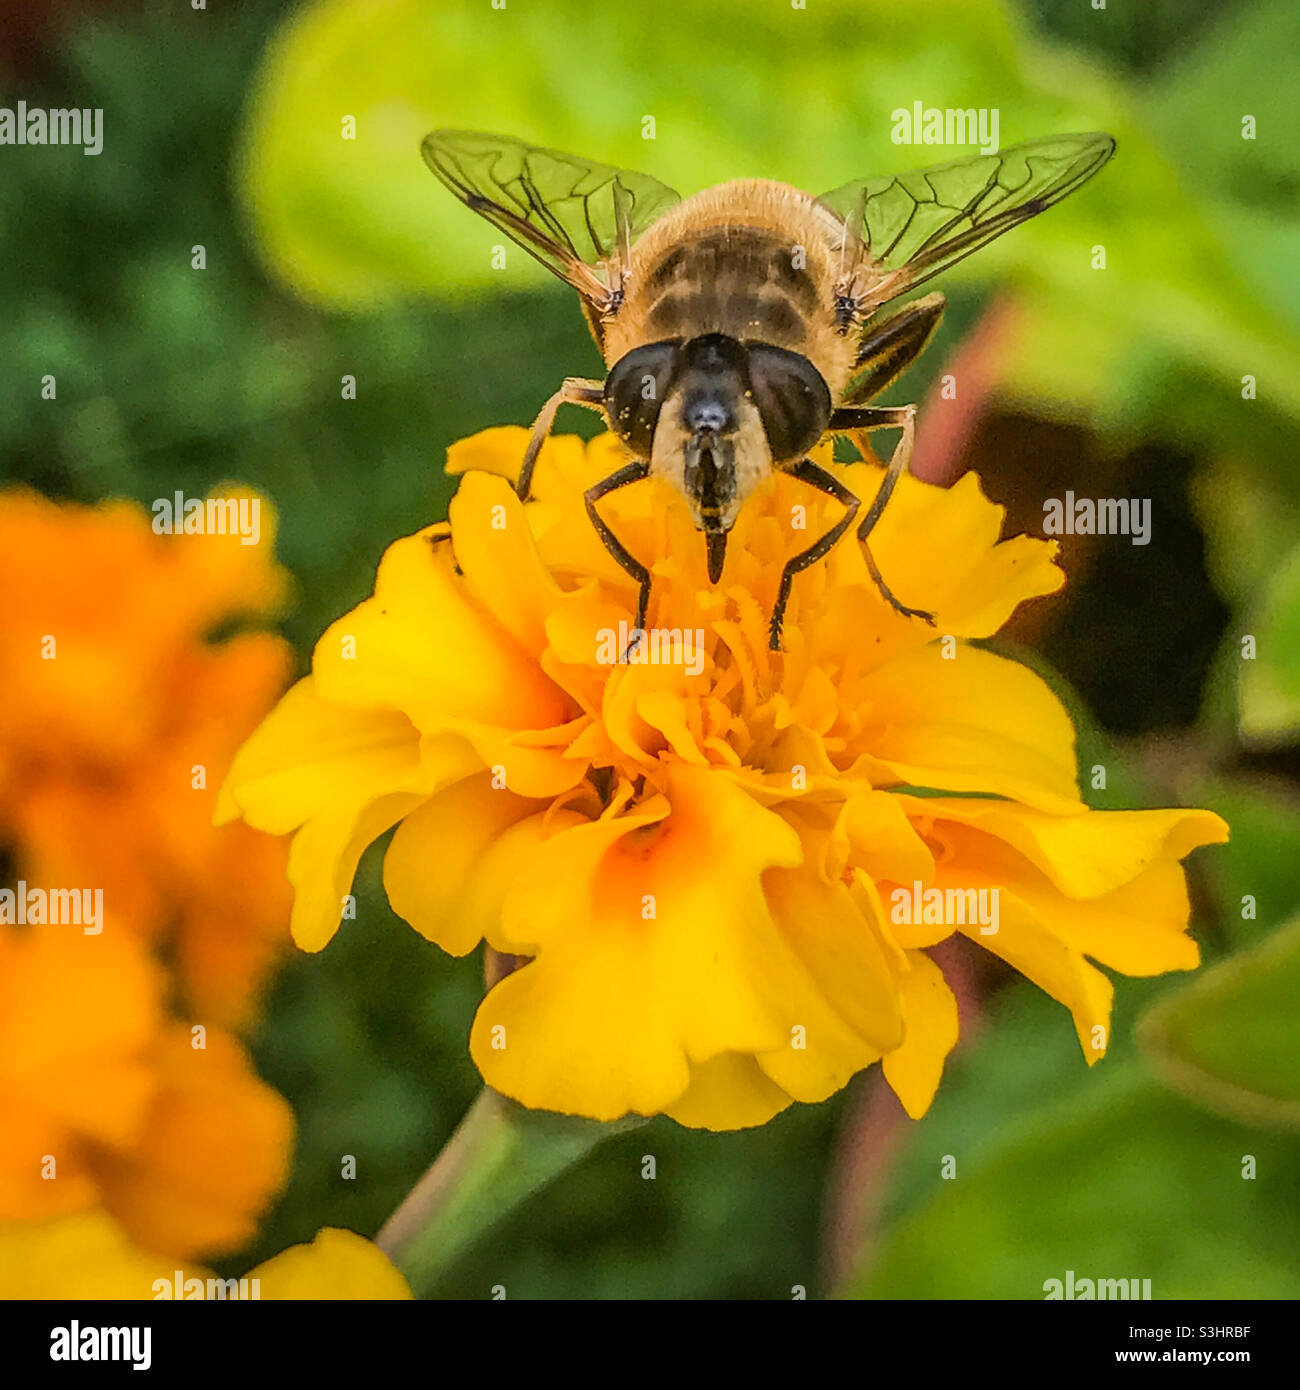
[220,428,1226,1129]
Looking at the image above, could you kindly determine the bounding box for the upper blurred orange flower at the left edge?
[0,489,292,1024]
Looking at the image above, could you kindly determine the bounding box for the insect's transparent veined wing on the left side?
[421,131,681,310]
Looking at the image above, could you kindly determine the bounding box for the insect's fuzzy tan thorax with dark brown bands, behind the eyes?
[603,179,852,391]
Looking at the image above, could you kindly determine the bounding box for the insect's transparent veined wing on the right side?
[819,132,1115,313]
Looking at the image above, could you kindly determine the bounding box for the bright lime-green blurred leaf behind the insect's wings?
[239,0,1028,307]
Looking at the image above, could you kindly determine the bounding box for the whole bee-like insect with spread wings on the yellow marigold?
[423,129,1115,651]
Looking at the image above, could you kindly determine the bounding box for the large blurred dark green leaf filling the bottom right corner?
[848,1062,1300,1300]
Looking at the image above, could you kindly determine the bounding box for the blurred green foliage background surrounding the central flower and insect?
[0,0,1300,1298]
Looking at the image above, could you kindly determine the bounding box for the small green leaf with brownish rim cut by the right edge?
[1139,919,1300,1129]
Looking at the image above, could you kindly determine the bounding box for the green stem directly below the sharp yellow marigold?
[375,1087,644,1297]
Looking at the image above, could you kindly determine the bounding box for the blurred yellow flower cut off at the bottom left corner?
[0,1211,412,1300]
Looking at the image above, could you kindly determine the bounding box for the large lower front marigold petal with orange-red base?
[470,765,824,1119]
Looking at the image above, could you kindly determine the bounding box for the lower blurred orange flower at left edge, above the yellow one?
[0,926,293,1257]
